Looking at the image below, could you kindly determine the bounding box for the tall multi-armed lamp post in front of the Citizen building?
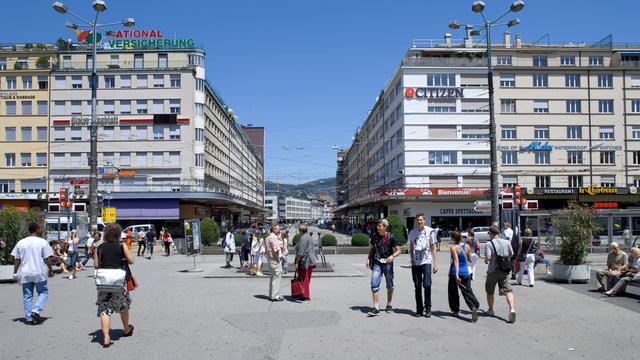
[449,0,524,225]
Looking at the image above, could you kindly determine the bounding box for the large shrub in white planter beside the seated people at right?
[552,203,600,283]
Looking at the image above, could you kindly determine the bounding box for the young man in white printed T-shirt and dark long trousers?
[409,213,438,317]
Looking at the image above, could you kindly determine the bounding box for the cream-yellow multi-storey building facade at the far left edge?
[0,43,56,209]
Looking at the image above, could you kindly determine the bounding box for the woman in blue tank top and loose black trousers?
[448,231,480,322]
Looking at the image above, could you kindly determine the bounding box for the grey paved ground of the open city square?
[0,252,640,359]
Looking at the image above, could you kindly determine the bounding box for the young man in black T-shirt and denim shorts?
[365,219,400,316]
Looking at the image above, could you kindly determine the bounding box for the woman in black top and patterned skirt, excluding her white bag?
[96,223,133,347]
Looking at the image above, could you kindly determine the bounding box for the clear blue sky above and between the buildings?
[0,0,640,183]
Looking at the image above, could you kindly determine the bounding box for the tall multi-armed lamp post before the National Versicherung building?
[52,0,135,225]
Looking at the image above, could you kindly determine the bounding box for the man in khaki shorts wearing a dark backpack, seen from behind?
[484,225,516,323]
